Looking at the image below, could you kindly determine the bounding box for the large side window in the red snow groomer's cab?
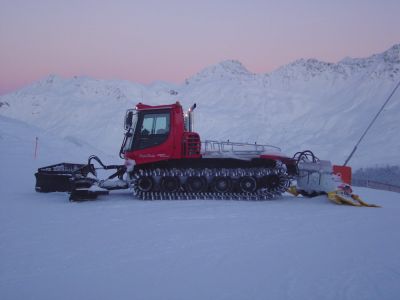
[135,112,170,149]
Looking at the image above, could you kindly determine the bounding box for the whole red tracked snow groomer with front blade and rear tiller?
[35,102,376,206]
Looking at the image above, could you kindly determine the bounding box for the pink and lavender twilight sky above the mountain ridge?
[0,0,400,94]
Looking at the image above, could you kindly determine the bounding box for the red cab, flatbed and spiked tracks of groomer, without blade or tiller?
[121,102,296,199]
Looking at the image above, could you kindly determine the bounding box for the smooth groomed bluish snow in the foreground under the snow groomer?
[0,107,400,300]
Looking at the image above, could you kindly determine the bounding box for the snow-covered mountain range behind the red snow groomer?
[0,44,400,167]
